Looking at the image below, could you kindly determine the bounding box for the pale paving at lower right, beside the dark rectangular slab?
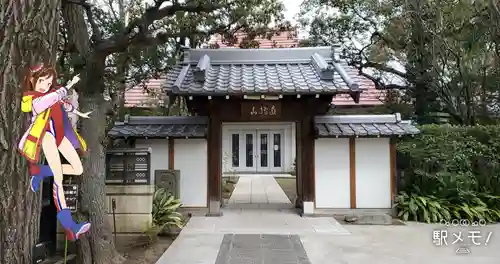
[300,223,500,264]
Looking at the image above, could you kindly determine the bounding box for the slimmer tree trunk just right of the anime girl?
[78,82,123,264]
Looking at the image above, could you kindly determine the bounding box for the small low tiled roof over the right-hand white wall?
[314,114,420,137]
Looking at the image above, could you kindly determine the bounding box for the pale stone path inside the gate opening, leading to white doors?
[226,176,293,209]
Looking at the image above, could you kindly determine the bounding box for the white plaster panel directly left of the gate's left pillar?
[174,139,208,207]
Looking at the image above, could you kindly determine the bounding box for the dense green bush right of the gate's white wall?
[396,125,500,222]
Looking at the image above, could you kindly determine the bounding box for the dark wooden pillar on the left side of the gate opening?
[207,101,222,216]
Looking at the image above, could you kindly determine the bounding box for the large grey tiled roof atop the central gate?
[165,47,363,95]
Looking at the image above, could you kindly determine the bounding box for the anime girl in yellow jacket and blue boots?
[18,64,90,241]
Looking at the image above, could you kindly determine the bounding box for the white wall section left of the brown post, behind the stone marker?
[135,139,168,184]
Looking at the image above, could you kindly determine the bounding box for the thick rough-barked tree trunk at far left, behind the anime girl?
[0,0,60,264]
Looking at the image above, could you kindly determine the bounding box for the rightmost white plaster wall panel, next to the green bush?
[356,138,391,209]
